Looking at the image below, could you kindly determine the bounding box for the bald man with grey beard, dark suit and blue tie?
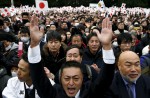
[106,51,150,98]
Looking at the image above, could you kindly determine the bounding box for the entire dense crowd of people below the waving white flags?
[0,7,150,98]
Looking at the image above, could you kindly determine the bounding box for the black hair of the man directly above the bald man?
[117,33,132,45]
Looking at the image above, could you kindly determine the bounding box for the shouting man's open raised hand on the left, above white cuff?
[30,15,44,48]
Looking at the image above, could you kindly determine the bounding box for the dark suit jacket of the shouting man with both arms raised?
[30,62,114,98]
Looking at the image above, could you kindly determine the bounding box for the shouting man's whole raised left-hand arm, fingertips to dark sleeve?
[28,15,55,98]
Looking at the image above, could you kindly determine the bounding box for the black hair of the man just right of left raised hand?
[46,30,61,42]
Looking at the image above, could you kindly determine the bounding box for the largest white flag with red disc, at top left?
[36,0,48,11]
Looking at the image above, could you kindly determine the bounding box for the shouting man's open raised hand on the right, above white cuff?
[97,18,113,48]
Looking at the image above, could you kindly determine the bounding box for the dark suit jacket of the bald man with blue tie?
[105,73,150,98]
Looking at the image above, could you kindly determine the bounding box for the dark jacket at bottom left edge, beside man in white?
[0,67,10,98]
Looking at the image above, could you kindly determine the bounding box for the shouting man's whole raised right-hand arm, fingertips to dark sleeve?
[90,18,115,98]
